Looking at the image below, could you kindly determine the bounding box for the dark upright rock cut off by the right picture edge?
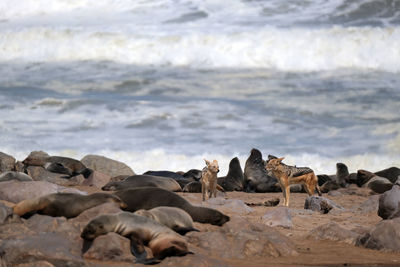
[378,181,400,220]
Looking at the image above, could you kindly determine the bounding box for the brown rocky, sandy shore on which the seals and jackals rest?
[0,151,400,267]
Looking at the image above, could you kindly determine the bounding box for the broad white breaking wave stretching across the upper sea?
[0,27,400,72]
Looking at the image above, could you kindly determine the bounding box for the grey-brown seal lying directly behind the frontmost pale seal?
[135,207,199,235]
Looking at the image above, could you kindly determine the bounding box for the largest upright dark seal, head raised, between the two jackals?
[244,148,278,193]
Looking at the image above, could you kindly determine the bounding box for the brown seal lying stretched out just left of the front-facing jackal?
[101,175,182,192]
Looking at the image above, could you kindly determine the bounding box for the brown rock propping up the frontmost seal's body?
[83,232,135,262]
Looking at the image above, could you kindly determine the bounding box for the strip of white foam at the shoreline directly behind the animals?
[0,147,400,176]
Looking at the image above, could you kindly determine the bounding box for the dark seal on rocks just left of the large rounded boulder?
[22,155,93,178]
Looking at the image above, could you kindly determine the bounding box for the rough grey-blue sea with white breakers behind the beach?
[0,0,400,174]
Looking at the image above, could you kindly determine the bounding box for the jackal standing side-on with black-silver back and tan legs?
[265,158,321,207]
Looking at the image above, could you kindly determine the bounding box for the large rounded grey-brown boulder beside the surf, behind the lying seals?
[81,155,135,177]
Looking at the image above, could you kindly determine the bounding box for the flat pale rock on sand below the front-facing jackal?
[202,197,253,214]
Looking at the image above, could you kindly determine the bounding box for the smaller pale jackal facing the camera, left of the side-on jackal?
[200,159,219,201]
